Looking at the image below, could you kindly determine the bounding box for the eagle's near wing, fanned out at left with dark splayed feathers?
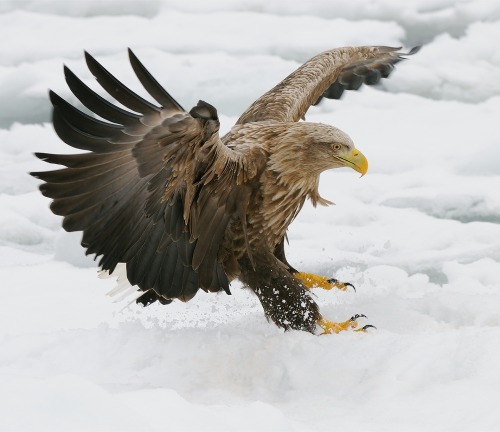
[32,51,254,301]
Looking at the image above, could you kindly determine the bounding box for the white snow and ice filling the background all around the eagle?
[0,0,500,431]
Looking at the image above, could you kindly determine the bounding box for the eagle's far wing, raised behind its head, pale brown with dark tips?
[237,47,420,124]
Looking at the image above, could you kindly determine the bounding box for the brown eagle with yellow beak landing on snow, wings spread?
[31,46,418,334]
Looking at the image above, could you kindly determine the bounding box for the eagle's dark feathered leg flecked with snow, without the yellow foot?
[238,250,321,333]
